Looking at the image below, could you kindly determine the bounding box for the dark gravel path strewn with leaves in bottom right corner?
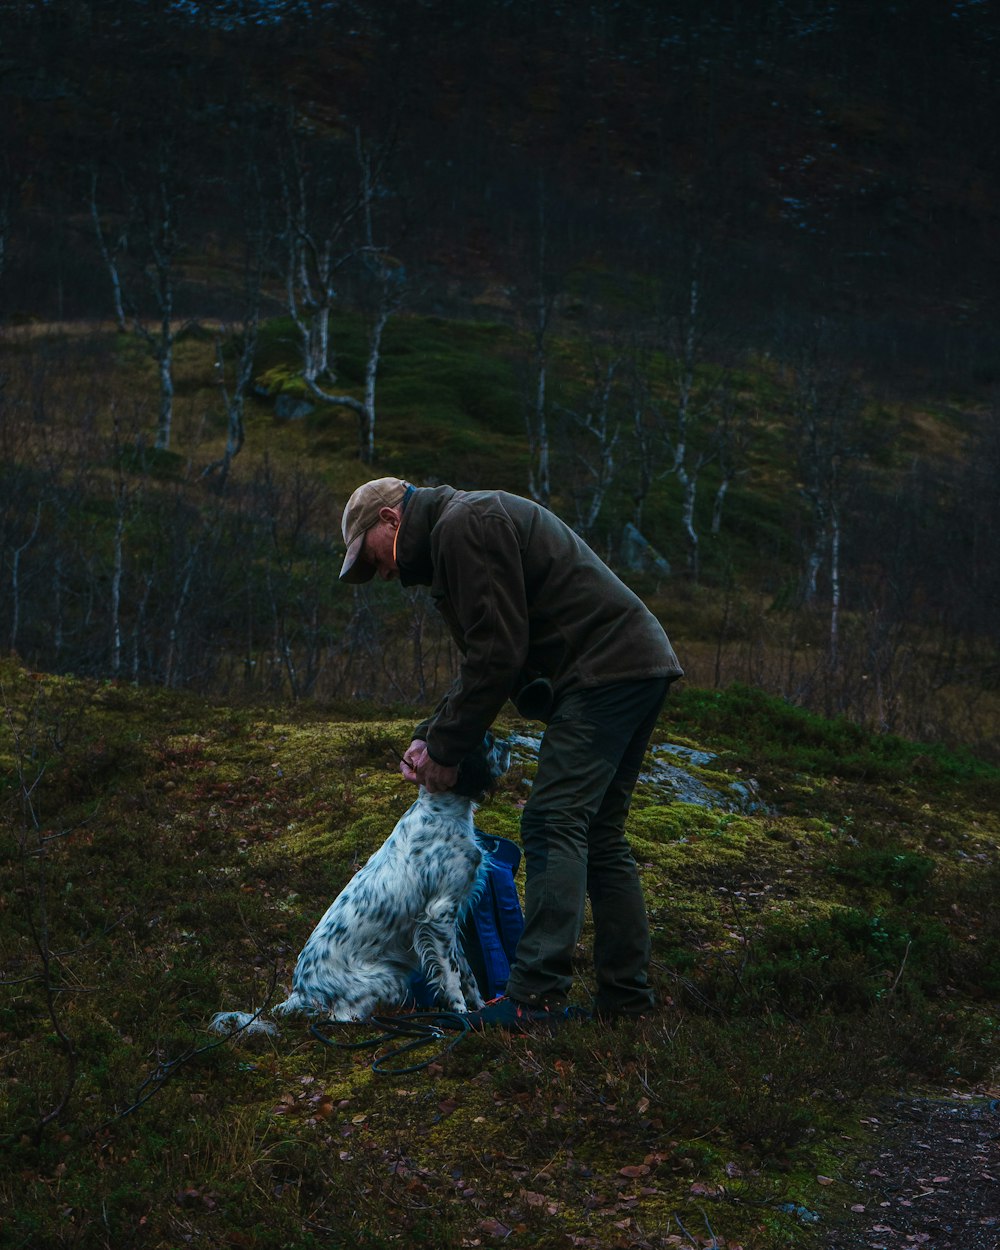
[823,1098,1000,1250]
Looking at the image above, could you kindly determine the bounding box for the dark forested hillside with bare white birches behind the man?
[0,0,1000,753]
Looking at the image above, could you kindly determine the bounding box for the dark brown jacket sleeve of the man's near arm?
[428,509,529,764]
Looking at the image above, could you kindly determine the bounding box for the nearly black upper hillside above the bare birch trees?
[0,0,1000,385]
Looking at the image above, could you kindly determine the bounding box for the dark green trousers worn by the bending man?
[508,678,670,1011]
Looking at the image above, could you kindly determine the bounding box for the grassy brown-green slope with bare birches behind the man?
[0,313,1000,758]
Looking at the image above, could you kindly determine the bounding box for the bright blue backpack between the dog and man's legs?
[410,829,524,1009]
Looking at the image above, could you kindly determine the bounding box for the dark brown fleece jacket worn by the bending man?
[396,486,683,764]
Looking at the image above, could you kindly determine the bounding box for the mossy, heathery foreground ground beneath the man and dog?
[0,664,1000,1250]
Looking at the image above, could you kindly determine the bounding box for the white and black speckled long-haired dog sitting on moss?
[210,735,510,1034]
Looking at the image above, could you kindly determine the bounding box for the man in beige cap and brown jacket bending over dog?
[340,478,681,1029]
